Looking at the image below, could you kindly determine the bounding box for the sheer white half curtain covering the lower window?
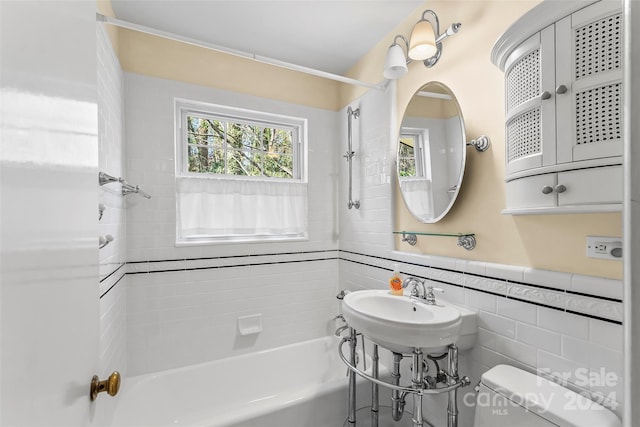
[176,177,307,242]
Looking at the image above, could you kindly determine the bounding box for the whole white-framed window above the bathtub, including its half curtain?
[176,100,307,244]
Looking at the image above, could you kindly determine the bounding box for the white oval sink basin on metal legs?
[342,290,462,354]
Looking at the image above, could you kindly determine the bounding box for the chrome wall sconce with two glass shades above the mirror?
[383,9,462,80]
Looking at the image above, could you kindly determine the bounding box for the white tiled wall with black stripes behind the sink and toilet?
[339,84,623,425]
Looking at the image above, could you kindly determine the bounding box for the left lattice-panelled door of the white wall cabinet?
[505,26,556,176]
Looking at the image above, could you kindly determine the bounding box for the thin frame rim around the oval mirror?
[396,81,467,224]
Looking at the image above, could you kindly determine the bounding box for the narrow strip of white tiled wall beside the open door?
[96,25,127,375]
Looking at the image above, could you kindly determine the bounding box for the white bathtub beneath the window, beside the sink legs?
[110,337,388,427]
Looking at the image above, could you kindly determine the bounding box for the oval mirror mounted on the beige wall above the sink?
[397,82,467,223]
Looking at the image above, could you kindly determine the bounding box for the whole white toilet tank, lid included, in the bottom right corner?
[473,365,622,427]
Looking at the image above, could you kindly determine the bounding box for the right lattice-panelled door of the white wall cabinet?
[555,0,623,163]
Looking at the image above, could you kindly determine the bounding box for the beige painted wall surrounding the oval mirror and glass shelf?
[341,0,622,279]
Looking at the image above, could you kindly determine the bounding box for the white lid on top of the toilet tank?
[481,365,622,427]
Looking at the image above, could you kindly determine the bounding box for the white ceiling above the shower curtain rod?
[111,0,424,74]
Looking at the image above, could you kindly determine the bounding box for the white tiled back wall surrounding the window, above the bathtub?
[120,73,339,375]
